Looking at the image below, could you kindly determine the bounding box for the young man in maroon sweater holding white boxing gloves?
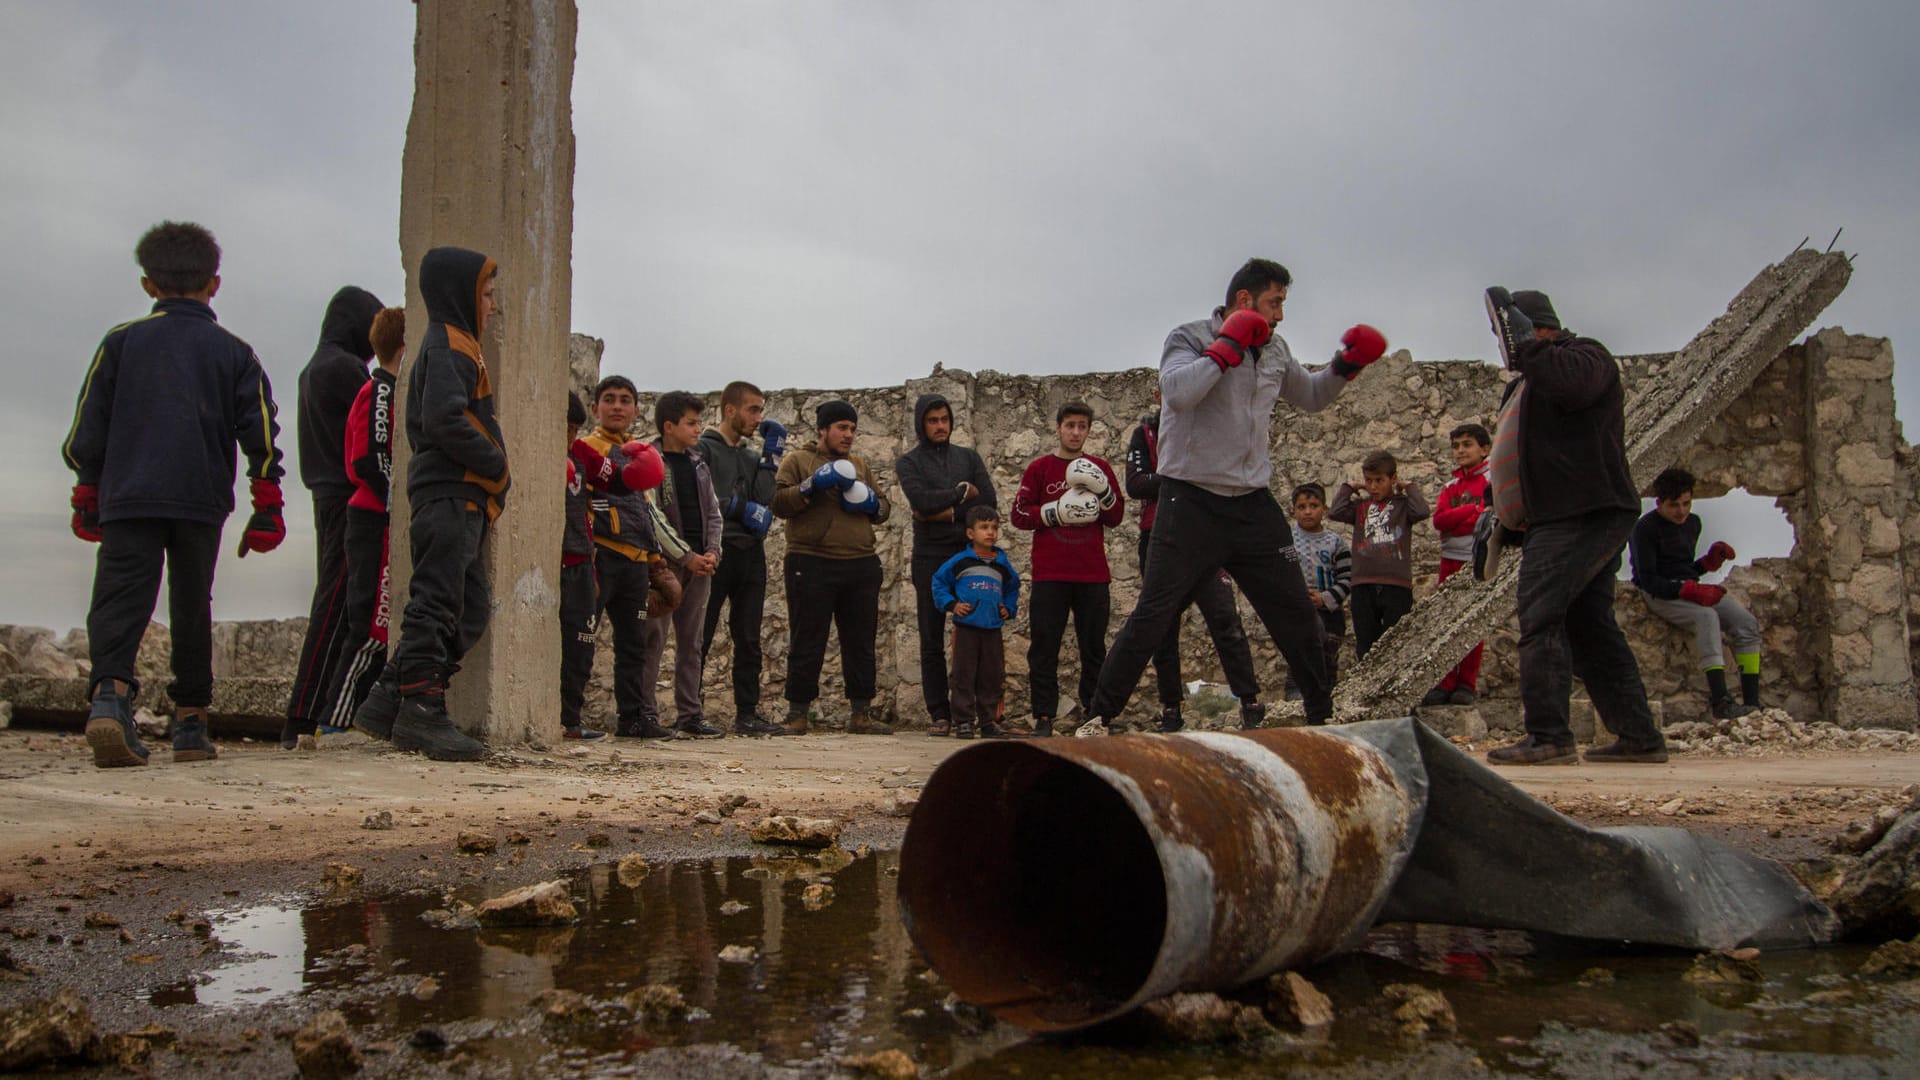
[1012,402,1127,736]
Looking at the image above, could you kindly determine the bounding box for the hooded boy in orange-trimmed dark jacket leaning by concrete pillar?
[353,248,511,761]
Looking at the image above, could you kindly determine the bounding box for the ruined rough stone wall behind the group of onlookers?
[0,331,1920,728]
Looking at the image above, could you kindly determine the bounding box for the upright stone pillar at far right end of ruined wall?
[1801,329,1914,730]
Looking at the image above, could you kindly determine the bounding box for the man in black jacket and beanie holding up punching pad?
[1486,286,1667,765]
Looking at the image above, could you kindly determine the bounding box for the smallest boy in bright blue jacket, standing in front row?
[931,505,1020,738]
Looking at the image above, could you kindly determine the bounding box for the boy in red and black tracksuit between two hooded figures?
[316,307,407,737]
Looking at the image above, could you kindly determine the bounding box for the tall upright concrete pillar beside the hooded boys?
[392,0,578,746]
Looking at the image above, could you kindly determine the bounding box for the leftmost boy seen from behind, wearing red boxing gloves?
[61,221,286,769]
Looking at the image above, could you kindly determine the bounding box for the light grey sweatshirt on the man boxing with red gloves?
[1160,307,1346,498]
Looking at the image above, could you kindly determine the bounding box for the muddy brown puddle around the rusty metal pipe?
[146,853,1920,1078]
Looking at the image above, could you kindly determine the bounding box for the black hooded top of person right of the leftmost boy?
[298,284,382,498]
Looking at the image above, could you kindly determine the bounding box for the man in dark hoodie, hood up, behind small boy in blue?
[893,394,1000,734]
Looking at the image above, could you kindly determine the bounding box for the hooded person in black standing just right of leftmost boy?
[280,284,382,749]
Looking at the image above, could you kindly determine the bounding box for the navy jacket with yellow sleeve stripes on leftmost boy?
[61,296,280,525]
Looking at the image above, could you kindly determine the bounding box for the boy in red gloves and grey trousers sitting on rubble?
[1628,469,1761,721]
